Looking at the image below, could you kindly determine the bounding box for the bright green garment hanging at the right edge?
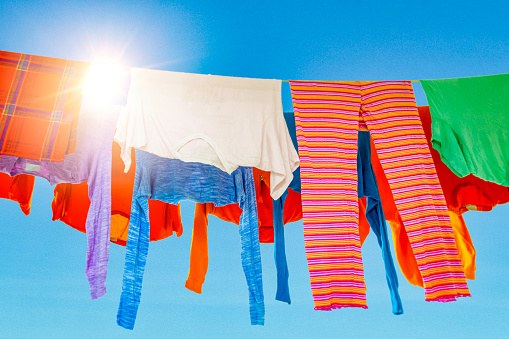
[421,74,509,186]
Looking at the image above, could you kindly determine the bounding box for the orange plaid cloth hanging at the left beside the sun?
[0,51,90,161]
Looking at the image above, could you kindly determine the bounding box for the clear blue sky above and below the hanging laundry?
[0,0,509,338]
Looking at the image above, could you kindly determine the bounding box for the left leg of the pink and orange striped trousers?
[290,82,367,310]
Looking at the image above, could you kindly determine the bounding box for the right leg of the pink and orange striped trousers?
[361,81,470,301]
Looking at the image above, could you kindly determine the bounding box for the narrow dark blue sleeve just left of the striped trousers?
[272,190,292,304]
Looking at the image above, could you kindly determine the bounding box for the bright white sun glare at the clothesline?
[84,59,128,103]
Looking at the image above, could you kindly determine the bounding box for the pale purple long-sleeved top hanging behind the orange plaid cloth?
[0,101,120,299]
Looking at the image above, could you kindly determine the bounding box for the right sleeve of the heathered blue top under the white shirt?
[239,167,265,325]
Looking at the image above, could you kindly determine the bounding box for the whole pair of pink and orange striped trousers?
[290,81,470,310]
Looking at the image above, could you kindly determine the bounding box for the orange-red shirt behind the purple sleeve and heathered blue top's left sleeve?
[51,142,183,246]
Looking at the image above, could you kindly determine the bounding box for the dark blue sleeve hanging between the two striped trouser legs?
[357,131,403,314]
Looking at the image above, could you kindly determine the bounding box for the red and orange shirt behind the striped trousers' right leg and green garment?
[371,106,509,287]
